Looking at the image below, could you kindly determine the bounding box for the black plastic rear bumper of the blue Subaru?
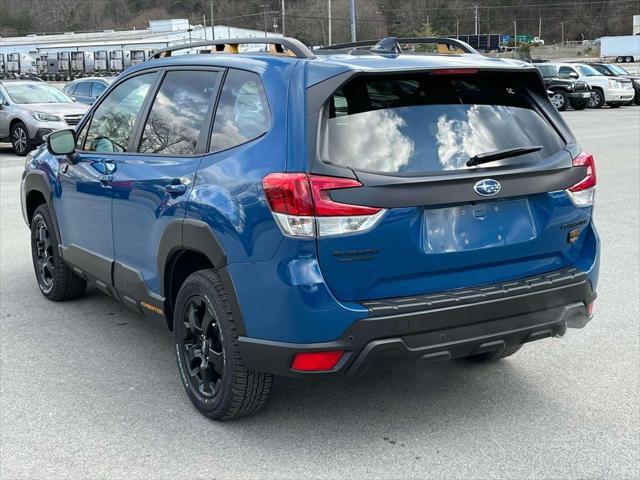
[239,269,596,377]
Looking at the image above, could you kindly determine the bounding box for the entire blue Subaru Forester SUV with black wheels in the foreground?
[21,38,599,420]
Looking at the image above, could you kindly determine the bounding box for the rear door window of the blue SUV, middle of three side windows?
[138,70,219,156]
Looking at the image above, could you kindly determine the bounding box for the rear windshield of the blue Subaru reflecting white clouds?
[319,74,564,175]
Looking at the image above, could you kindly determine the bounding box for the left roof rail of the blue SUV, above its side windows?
[149,37,315,60]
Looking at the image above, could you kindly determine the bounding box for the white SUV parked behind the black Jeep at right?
[555,63,635,108]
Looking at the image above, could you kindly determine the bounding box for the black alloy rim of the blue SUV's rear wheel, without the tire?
[180,295,225,399]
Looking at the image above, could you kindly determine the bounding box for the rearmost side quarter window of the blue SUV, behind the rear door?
[209,70,271,152]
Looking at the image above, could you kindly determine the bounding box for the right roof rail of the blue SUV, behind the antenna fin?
[314,37,478,55]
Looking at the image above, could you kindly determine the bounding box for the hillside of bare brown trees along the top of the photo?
[0,0,640,45]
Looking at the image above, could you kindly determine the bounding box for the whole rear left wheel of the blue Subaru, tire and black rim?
[173,270,273,420]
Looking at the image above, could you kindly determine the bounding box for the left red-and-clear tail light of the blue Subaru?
[262,173,385,237]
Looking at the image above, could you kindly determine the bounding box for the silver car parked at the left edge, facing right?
[0,80,89,156]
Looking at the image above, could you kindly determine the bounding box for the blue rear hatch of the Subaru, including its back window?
[311,69,591,301]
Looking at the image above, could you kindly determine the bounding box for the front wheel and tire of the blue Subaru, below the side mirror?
[31,205,87,301]
